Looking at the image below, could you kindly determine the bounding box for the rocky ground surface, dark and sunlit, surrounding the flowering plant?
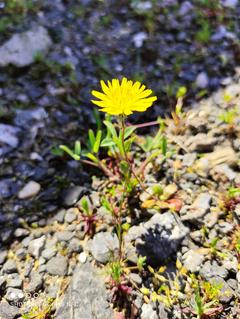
[0,0,240,319]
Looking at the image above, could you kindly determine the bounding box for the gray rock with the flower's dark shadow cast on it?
[125,212,189,266]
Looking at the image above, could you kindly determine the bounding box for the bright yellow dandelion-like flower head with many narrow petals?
[92,78,157,115]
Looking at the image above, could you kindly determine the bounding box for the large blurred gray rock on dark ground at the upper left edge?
[0,26,52,67]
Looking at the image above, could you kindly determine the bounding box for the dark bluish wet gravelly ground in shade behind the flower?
[0,0,240,243]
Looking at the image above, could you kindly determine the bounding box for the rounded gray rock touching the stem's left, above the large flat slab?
[88,232,119,264]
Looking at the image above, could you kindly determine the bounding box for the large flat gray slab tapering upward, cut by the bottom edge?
[55,263,114,319]
